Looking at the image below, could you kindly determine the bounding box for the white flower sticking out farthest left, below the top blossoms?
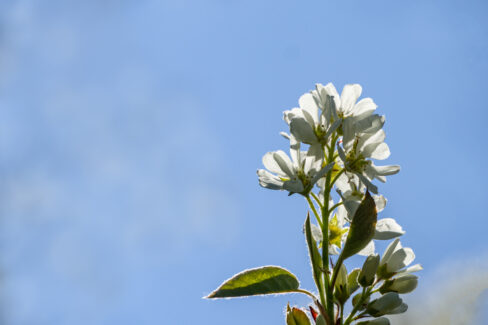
[257,136,333,194]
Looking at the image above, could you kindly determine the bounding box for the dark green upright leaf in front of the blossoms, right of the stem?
[341,191,377,260]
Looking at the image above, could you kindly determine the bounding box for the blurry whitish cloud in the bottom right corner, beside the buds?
[390,254,488,325]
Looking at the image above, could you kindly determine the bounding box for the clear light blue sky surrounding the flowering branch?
[0,0,488,325]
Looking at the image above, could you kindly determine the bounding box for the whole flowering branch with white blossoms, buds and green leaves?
[207,83,422,325]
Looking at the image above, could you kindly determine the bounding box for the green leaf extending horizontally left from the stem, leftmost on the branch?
[206,266,300,298]
